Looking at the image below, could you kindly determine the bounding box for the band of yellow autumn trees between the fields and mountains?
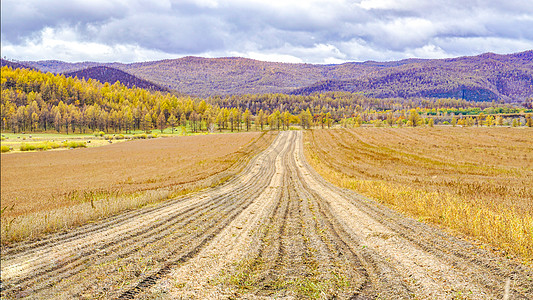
[0,67,531,133]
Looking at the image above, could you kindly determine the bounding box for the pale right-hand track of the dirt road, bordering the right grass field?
[299,131,533,299]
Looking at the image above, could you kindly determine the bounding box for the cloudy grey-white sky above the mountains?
[1,0,533,63]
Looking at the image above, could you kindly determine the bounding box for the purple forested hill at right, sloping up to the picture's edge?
[292,51,533,101]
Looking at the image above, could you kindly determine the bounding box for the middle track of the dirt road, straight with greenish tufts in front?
[139,132,402,299]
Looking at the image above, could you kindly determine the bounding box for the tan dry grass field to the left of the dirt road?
[1,133,273,243]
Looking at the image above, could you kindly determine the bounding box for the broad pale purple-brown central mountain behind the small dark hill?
[19,56,382,97]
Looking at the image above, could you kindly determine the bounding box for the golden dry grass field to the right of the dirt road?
[305,128,533,261]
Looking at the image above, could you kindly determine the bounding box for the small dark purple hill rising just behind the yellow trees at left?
[64,66,168,91]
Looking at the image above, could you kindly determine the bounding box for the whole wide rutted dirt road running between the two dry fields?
[1,131,533,299]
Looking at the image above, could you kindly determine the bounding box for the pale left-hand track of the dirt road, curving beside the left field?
[2,132,286,298]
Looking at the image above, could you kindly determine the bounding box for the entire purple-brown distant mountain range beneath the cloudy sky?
[5,50,533,102]
